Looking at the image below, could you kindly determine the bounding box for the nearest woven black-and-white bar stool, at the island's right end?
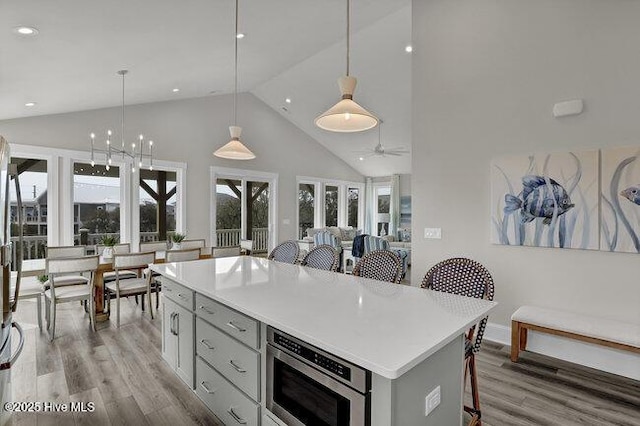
[421,257,494,425]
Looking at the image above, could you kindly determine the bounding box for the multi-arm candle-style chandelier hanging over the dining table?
[89,70,153,173]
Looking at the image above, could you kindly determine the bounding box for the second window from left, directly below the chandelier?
[73,162,121,245]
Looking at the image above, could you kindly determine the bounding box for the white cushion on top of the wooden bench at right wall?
[511,306,640,348]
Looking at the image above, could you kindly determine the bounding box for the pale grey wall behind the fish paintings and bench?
[412,0,640,332]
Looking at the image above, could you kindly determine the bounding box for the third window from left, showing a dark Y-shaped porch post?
[140,170,178,242]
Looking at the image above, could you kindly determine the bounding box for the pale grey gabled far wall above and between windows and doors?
[0,94,364,245]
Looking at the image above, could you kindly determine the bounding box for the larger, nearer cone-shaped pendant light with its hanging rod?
[315,0,378,133]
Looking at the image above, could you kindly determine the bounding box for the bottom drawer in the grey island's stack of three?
[196,358,260,426]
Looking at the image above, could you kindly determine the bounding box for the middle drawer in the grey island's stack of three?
[196,318,260,401]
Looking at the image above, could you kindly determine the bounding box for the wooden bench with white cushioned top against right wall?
[511,306,640,362]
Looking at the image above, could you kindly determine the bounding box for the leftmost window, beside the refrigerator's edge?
[9,157,48,265]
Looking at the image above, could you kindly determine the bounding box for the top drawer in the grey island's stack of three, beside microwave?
[196,294,260,349]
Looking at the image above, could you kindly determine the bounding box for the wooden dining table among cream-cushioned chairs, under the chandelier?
[22,247,213,322]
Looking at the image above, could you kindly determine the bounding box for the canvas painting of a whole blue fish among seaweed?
[491,151,599,250]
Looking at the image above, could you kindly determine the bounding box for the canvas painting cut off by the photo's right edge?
[600,147,640,253]
